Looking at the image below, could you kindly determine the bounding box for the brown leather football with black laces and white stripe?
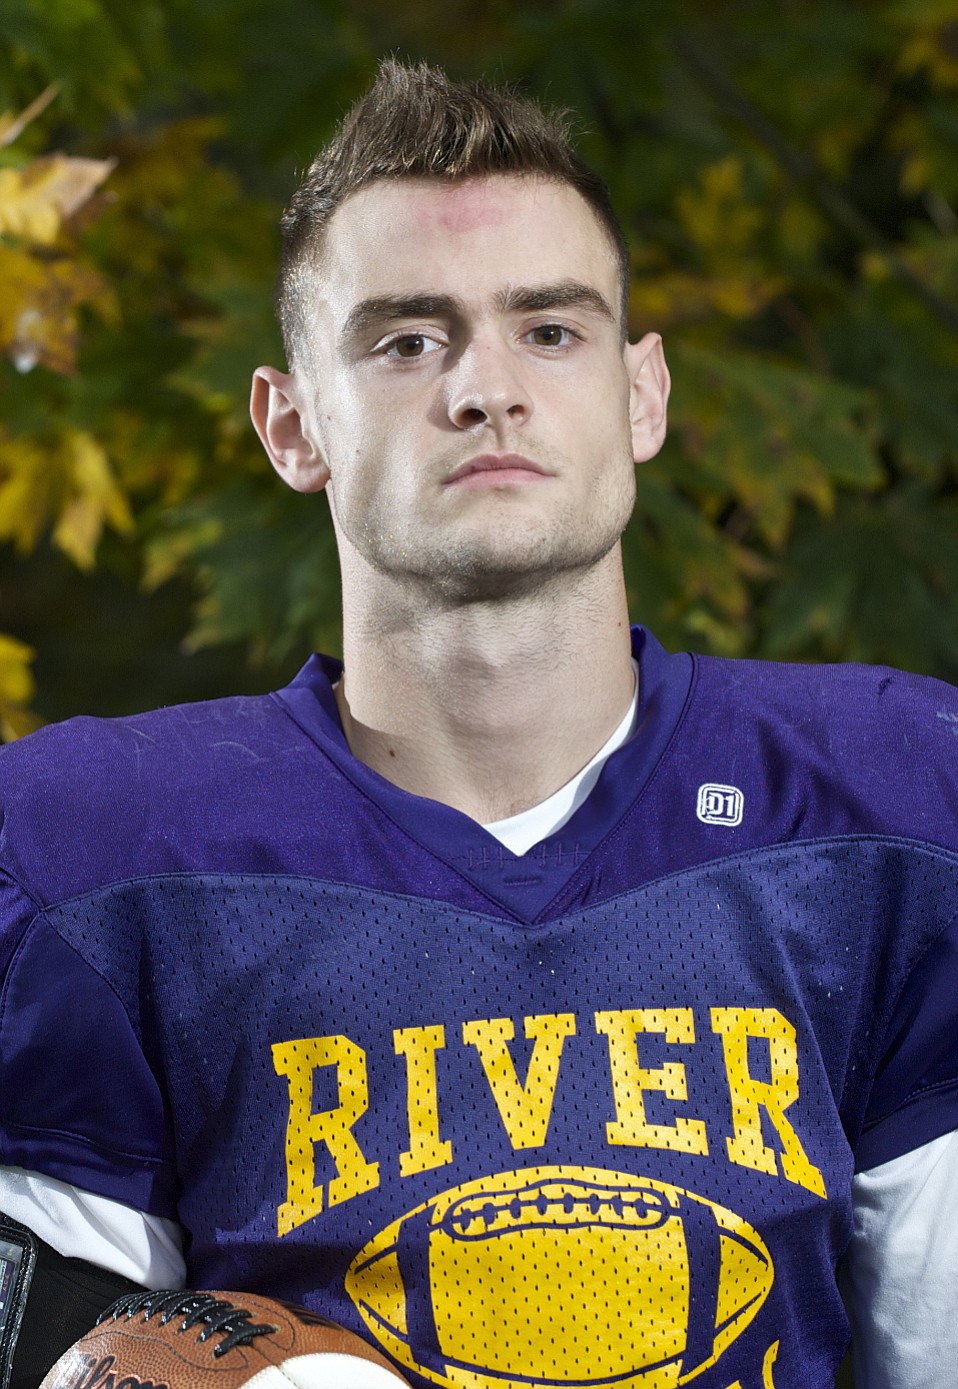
[40,1292,405,1389]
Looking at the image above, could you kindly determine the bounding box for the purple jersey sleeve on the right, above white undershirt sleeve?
[855,915,958,1172]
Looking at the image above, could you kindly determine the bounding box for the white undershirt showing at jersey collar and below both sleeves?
[0,661,958,1389]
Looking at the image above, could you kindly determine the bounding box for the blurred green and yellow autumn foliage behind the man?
[0,0,958,738]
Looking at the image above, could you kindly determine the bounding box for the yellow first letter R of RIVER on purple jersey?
[272,1036,379,1236]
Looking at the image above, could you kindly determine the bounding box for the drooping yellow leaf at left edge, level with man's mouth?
[0,429,133,569]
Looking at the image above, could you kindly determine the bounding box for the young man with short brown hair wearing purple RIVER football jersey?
[0,56,958,1389]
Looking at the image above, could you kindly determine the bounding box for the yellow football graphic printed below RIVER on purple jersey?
[346,1167,775,1389]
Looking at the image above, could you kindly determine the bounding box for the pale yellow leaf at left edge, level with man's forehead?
[0,154,117,246]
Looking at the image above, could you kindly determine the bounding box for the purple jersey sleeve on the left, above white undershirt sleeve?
[0,876,176,1218]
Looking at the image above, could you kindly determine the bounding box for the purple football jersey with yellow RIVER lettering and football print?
[0,631,958,1389]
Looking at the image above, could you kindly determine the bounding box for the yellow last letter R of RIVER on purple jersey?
[712,1008,825,1197]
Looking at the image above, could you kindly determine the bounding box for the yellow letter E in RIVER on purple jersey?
[596,1008,708,1153]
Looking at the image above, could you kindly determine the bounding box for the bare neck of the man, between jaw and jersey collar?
[336,557,633,822]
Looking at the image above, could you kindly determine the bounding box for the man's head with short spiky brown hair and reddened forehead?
[251,64,668,611]
